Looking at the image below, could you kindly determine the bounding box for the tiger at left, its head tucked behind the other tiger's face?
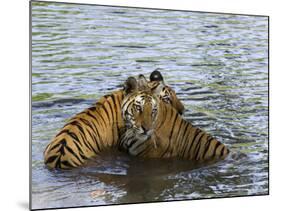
[43,71,184,169]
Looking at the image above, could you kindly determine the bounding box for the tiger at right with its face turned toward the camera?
[119,79,230,162]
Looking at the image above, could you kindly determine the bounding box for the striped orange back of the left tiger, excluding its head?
[44,90,124,169]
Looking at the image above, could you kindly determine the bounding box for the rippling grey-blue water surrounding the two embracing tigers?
[32,2,268,209]
